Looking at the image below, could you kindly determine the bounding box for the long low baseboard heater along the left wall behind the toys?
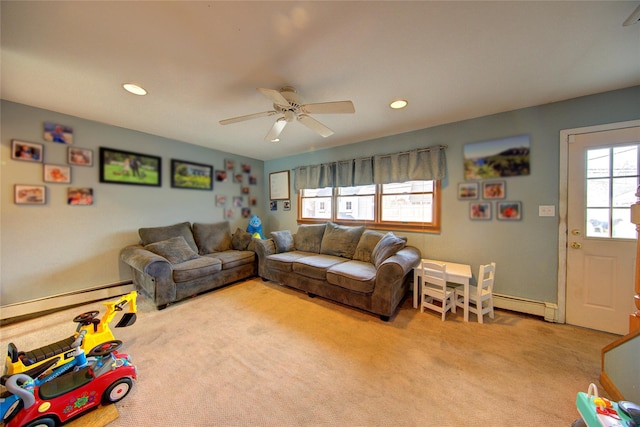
[0,280,134,320]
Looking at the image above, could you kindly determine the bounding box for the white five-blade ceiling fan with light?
[220,86,356,142]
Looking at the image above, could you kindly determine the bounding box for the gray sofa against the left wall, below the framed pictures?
[120,222,257,309]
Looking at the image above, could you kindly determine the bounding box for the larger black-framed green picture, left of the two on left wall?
[100,147,162,187]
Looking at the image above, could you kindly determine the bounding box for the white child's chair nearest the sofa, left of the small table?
[418,261,456,321]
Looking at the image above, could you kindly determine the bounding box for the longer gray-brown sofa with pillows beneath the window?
[255,222,421,321]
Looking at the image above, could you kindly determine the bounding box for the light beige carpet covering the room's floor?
[0,279,617,427]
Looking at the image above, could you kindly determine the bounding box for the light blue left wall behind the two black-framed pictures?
[0,101,268,305]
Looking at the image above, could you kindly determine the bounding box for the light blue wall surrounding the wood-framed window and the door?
[263,87,640,303]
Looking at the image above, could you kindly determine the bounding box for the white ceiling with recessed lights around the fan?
[1,0,640,160]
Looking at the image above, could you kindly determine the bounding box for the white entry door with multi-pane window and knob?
[566,127,640,334]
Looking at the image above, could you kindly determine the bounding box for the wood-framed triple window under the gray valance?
[298,181,440,232]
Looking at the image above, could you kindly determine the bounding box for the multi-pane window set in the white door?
[585,145,639,239]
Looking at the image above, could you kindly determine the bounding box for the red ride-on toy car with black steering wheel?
[3,341,137,427]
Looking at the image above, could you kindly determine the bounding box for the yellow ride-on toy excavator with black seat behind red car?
[3,291,138,380]
